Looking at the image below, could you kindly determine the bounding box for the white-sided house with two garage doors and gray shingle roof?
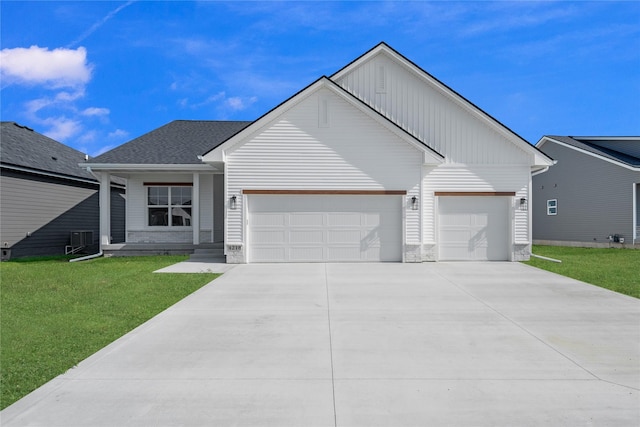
[86,43,553,263]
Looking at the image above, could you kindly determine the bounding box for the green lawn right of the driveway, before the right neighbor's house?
[525,246,640,298]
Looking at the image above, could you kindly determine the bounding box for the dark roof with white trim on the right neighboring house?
[536,135,640,170]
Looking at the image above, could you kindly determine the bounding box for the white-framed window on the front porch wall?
[147,185,192,227]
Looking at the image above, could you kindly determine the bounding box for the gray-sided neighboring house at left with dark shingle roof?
[0,122,125,260]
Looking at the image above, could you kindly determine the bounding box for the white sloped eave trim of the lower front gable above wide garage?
[203,76,443,164]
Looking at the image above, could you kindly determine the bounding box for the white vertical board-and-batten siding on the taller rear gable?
[336,52,533,165]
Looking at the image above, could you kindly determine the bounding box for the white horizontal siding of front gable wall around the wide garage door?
[225,89,423,244]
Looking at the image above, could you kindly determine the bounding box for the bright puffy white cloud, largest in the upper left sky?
[0,46,92,89]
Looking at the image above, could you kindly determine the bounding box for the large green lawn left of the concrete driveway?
[0,256,217,408]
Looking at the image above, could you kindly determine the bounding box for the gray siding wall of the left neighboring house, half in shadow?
[0,170,99,258]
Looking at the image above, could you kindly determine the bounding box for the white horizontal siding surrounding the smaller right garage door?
[422,165,530,245]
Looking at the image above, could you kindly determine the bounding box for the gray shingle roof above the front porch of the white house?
[89,120,251,165]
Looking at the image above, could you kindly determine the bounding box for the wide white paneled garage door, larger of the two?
[248,195,402,262]
